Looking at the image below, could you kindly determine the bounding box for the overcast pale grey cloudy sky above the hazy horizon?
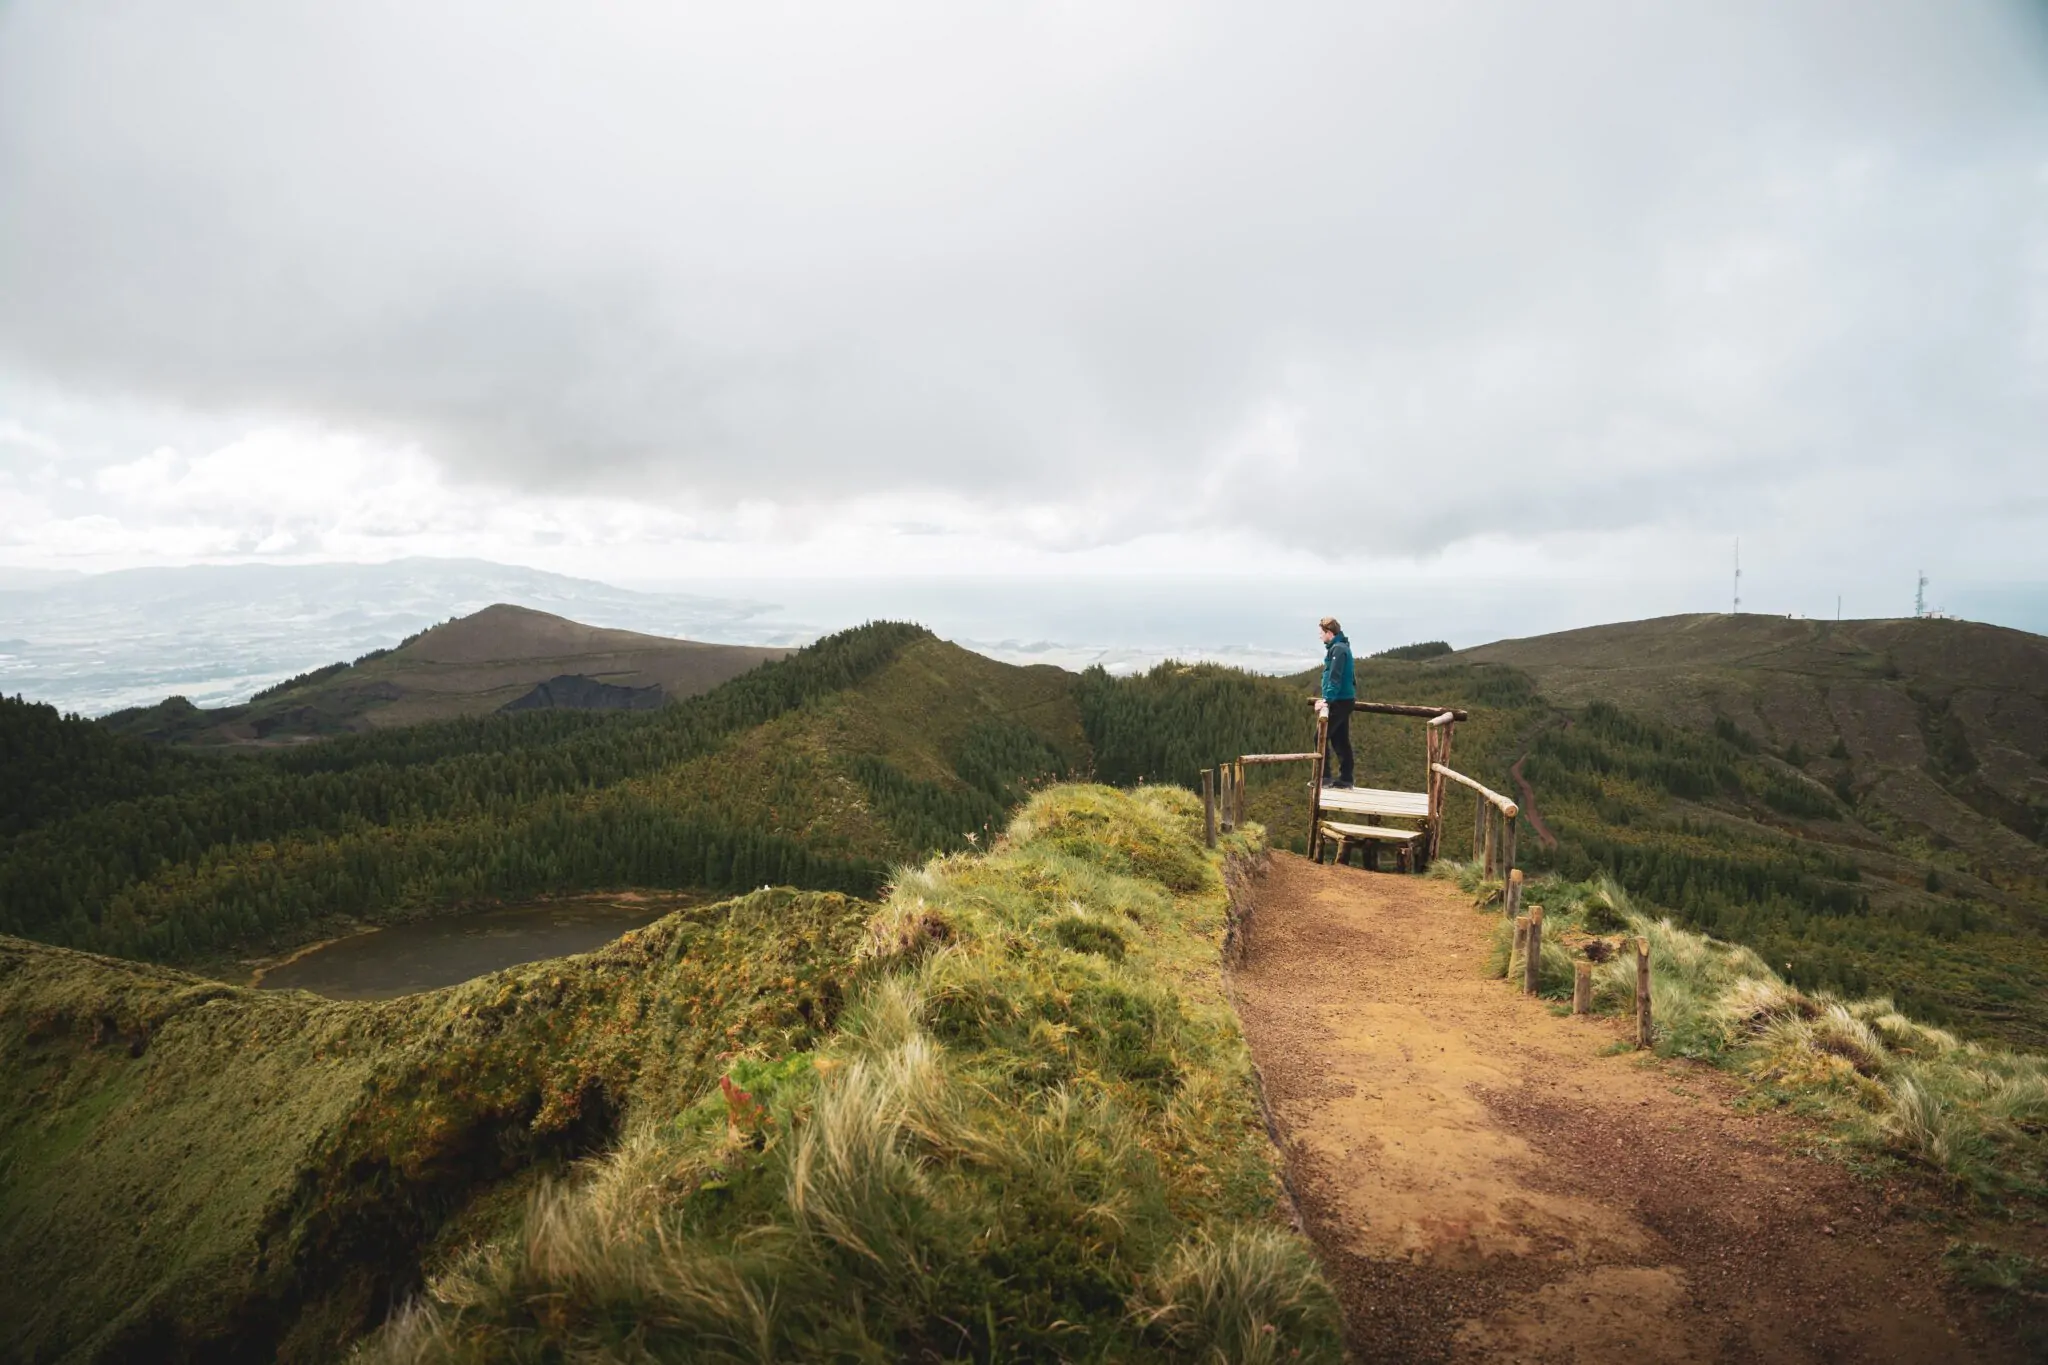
[0,0,2048,614]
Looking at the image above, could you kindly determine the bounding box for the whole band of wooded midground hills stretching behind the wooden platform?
[16,601,2048,1046]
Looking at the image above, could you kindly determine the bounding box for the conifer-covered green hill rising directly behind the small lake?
[0,624,1085,962]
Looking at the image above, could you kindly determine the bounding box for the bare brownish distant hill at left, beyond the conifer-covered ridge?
[100,604,788,745]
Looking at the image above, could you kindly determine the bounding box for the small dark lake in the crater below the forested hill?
[262,896,688,1001]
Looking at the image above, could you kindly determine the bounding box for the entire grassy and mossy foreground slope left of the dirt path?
[0,788,1339,1361]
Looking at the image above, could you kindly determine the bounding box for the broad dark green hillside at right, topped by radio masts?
[1423,616,2048,1048]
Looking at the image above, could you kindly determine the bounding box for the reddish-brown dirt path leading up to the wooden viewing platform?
[1233,853,2005,1365]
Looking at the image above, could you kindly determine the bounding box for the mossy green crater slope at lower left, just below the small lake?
[0,892,866,1361]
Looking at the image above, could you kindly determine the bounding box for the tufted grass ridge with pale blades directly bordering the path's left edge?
[369,788,1337,1361]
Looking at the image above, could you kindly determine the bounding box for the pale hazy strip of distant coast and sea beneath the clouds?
[0,559,2048,714]
